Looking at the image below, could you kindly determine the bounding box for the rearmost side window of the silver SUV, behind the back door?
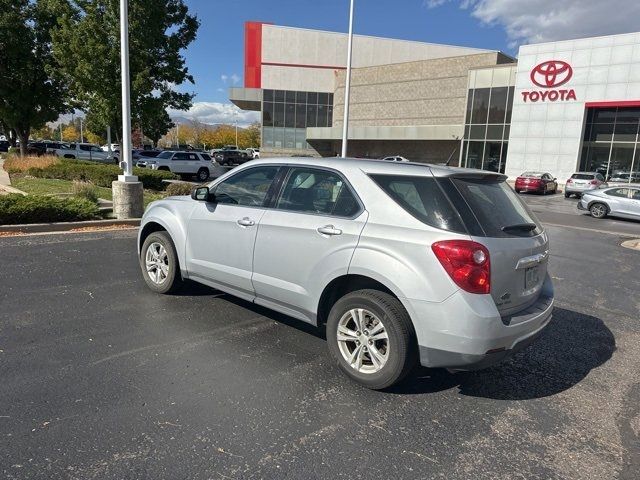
[371,175,466,233]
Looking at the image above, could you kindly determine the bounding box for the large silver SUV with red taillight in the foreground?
[138,158,553,389]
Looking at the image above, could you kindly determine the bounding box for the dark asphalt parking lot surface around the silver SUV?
[0,220,640,480]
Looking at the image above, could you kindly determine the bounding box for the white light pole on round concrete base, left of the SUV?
[112,0,144,219]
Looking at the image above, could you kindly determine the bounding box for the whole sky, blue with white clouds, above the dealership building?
[170,0,640,124]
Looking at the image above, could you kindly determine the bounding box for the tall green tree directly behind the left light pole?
[47,0,199,144]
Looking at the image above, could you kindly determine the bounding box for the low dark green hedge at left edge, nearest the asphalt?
[0,194,99,225]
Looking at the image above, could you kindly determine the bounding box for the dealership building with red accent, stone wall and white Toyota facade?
[229,22,640,183]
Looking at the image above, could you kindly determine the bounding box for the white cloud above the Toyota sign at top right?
[425,0,640,46]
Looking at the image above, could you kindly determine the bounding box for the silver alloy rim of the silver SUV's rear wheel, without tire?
[337,308,389,374]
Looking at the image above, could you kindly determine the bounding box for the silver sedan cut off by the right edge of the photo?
[578,186,640,219]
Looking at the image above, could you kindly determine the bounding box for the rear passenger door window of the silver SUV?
[276,167,360,217]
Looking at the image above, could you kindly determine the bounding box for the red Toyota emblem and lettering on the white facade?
[521,60,577,103]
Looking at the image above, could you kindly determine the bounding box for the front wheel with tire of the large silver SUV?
[140,231,183,293]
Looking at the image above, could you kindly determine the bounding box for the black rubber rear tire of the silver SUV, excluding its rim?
[327,290,418,390]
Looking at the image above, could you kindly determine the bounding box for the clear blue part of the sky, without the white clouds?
[180,0,514,102]
